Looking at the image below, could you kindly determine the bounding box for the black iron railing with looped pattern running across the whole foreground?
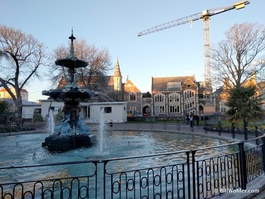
[0,132,265,199]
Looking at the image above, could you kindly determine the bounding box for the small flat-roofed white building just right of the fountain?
[89,102,127,123]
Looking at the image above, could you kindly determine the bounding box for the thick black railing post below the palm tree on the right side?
[238,142,247,190]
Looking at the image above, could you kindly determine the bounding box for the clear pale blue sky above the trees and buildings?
[0,0,265,101]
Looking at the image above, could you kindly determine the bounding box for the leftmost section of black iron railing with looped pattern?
[0,162,98,199]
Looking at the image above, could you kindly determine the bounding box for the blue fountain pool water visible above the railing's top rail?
[0,131,231,167]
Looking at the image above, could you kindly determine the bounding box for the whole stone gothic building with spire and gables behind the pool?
[92,60,218,116]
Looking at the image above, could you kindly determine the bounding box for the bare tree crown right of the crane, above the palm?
[211,23,265,88]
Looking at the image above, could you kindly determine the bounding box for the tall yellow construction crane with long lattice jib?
[138,1,250,91]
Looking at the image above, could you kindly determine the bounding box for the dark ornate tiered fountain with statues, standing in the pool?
[42,31,96,152]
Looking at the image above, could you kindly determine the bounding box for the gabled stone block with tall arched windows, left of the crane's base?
[152,76,215,116]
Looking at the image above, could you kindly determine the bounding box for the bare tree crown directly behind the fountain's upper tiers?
[52,40,111,90]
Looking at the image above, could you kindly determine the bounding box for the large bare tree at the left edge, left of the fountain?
[0,26,46,118]
